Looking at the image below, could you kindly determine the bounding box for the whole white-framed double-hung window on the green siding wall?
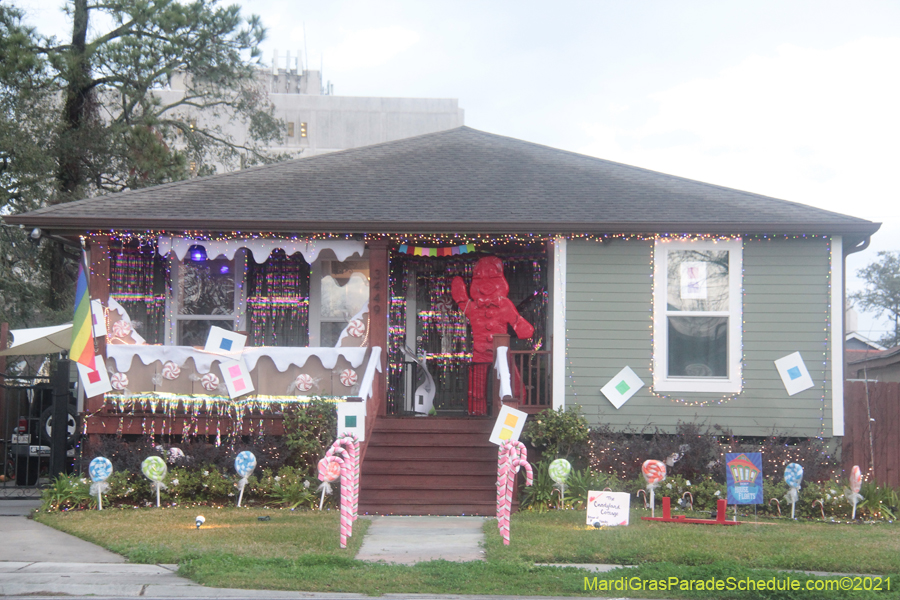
[653,240,742,393]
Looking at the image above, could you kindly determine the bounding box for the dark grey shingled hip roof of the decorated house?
[5,127,880,238]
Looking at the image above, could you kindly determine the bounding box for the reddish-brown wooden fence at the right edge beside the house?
[841,381,900,487]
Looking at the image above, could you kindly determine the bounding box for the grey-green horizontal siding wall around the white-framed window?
[566,238,831,437]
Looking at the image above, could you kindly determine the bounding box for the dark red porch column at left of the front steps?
[367,240,391,418]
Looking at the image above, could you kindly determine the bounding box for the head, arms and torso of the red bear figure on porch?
[450,256,534,363]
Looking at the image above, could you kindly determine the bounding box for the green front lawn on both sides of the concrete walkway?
[36,508,900,599]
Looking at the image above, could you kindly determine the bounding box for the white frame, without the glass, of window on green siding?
[653,238,743,394]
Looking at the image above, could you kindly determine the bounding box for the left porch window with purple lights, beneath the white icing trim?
[167,246,245,346]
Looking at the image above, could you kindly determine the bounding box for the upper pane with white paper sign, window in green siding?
[666,250,728,311]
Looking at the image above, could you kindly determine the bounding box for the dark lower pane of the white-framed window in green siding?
[668,317,728,378]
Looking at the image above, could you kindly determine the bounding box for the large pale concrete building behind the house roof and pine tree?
[156,53,465,163]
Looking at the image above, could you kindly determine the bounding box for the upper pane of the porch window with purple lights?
[178,258,234,315]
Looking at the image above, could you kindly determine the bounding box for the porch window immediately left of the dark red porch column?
[309,260,369,347]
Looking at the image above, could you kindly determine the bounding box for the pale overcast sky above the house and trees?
[13,0,900,339]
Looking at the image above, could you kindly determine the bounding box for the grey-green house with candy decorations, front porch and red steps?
[6,127,879,514]
